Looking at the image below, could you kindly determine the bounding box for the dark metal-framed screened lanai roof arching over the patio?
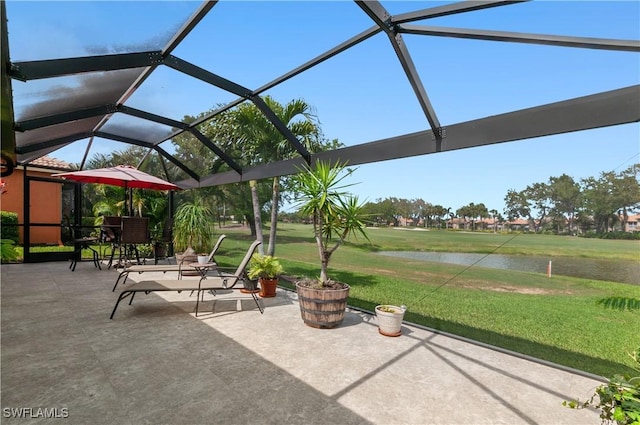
[2,0,640,256]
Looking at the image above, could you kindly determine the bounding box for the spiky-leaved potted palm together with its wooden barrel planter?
[293,161,369,328]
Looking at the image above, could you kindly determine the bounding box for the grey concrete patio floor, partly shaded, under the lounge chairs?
[1,262,600,425]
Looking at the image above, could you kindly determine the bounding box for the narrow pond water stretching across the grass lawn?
[380,251,640,285]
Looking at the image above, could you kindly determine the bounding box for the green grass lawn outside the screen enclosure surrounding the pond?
[216,224,640,376]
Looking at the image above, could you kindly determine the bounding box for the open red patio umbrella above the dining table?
[53,165,182,215]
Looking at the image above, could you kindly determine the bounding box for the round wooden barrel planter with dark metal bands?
[296,282,350,329]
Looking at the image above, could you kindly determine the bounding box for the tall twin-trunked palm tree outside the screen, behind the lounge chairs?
[236,96,320,256]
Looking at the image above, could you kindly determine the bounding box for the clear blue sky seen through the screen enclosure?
[7,1,640,211]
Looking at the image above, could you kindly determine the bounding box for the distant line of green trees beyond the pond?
[286,164,640,235]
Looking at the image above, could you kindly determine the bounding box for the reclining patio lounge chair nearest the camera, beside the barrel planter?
[109,240,264,319]
